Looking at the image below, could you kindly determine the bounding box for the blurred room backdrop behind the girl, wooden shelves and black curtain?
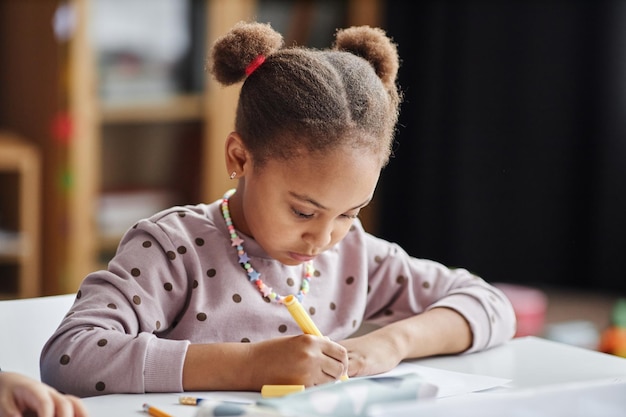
[0,0,626,354]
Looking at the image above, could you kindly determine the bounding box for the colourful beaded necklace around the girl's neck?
[222,189,315,303]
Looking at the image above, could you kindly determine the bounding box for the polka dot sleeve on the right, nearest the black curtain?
[358,234,516,353]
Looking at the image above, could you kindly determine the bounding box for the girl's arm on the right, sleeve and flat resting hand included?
[341,229,516,375]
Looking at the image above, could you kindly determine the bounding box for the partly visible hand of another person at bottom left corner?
[0,372,87,417]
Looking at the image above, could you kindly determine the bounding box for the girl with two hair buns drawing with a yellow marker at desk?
[41,23,515,396]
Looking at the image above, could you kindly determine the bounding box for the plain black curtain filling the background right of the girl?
[377,0,626,294]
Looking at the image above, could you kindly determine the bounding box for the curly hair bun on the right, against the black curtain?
[334,26,400,88]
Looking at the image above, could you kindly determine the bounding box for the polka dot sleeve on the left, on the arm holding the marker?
[40,220,197,397]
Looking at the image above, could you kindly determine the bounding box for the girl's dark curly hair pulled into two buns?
[207,22,401,166]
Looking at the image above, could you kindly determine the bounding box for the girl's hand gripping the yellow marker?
[250,334,348,387]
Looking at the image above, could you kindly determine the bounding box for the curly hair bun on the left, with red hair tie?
[207,22,283,85]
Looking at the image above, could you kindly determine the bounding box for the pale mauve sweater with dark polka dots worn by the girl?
[41,197,515,397]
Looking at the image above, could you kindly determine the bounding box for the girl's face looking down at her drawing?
[234,145,381,265]
